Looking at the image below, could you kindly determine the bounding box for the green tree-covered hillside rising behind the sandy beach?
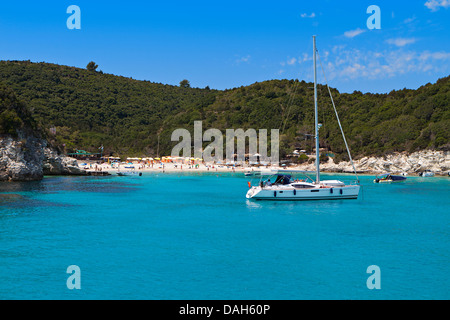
[0,61,450,157]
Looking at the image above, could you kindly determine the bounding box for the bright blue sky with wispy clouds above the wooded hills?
[0,0,450,92]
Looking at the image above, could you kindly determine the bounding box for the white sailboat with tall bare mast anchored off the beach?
[246,36,360,200]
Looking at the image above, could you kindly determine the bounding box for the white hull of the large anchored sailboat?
[246,185,360,201]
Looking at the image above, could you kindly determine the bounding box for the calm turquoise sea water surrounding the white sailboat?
[0,173,450,300]
